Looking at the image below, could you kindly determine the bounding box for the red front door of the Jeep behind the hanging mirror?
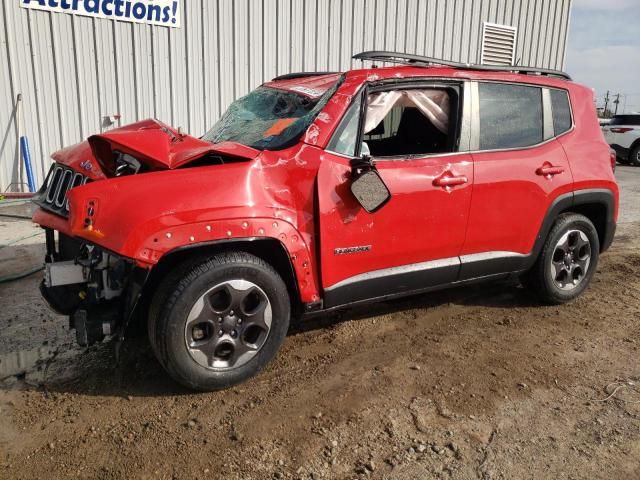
[318,82,473,307]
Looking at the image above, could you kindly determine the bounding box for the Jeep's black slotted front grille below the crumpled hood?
[33,164,91,217]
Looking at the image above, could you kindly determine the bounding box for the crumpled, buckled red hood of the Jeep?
[52,119,260,179]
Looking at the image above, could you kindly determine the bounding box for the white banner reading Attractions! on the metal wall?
[19,0,180,27]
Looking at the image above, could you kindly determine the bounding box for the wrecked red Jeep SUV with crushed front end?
[33,52,618,390]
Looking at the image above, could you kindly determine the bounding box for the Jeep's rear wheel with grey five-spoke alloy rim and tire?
[523,214,600,305]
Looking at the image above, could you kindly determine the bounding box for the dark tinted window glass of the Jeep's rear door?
[478,83,543,150]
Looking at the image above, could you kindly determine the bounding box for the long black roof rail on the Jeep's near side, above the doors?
[353,50,571,80]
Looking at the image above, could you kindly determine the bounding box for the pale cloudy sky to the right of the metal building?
[565,0,640,113]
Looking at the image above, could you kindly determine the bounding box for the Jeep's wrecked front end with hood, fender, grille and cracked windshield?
[33,74,341,345]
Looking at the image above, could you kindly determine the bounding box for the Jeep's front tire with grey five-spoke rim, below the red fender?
[149,252,291,391]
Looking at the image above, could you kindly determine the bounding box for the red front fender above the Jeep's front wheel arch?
[68,163,319,302]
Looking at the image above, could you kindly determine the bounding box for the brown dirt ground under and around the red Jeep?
[0,169,640,479]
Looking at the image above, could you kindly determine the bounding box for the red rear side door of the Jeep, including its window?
[461,82,573,280]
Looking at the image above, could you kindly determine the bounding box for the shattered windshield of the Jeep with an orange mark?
[202,84,338,150]
